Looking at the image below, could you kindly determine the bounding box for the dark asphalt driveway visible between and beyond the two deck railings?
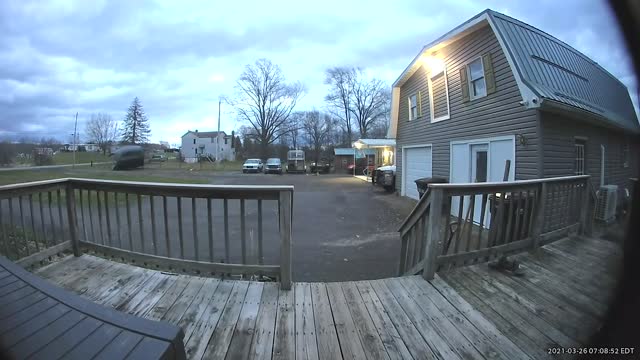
[205,174,414,281]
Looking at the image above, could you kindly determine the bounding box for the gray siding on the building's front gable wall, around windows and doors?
[396,23,539,189]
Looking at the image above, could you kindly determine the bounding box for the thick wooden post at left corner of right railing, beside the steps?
[422,188,442,280]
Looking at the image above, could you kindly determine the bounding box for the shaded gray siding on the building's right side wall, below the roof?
[540,112,640,194]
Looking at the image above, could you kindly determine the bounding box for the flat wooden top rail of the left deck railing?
[0,178,294,193]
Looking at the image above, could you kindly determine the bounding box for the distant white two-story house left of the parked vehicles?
[180,130,236,162]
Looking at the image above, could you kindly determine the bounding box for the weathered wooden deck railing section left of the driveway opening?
[0,179,293,289]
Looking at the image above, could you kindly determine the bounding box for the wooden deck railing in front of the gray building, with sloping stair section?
[399,175,590,279]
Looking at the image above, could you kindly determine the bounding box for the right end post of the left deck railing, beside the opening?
[278,191,293,290]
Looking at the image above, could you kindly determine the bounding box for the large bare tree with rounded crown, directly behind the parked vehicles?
[229,59,304,157]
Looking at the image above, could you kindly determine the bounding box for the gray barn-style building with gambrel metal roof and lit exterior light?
[388,10,640,202]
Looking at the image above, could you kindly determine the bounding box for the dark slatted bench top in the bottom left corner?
[0,256,185,359]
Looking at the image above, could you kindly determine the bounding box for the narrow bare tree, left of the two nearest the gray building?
[324,67,357,144]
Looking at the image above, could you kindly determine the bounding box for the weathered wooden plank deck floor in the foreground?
[31,235,621,359]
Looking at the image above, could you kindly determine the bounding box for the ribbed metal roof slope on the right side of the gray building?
[488,10,640,131]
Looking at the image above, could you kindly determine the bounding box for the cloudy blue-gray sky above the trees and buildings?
[0,0,638,143]
